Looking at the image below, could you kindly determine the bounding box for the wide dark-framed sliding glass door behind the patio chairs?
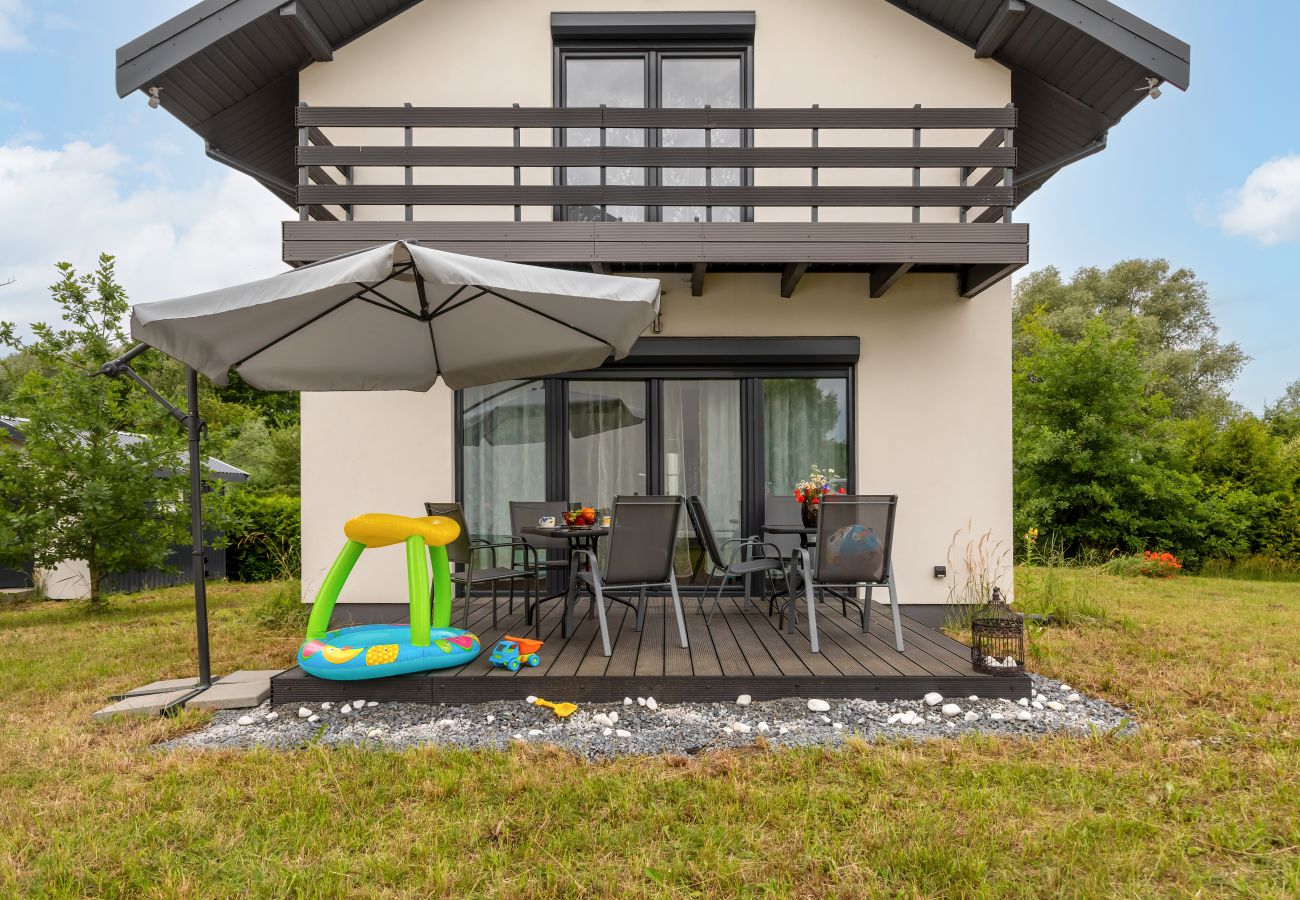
[459,367,853,584]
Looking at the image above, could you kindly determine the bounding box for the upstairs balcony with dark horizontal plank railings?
[283,105,1028,297]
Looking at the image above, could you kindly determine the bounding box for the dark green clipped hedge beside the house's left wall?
[226,490,302,581]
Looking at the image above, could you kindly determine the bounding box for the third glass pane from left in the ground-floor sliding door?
[663,380,741,584]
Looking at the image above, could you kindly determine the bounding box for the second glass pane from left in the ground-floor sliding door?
[568,380,646,510]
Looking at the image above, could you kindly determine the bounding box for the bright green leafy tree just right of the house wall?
[1013,316,1197,554]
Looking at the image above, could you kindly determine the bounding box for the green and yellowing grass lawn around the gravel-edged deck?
[0,571,1300,897]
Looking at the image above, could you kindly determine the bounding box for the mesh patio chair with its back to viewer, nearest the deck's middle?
[573,497,689,655]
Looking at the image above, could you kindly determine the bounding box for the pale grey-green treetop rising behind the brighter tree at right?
[1013,259,1247,420]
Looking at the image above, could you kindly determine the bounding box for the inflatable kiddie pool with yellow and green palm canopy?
[298,512,481,682]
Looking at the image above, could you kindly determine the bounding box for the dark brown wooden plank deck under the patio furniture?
[272,597,1030,704]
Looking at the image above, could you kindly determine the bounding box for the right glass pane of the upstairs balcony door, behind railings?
[659,56,742,222]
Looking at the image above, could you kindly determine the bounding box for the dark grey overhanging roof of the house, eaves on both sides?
[117,0,1191,203]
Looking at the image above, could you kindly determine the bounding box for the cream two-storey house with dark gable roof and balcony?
[117,0,1190,619]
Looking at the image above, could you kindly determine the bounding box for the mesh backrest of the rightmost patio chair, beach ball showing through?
[814,494,898,584]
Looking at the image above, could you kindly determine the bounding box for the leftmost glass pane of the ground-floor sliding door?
[460,381,546,541]
